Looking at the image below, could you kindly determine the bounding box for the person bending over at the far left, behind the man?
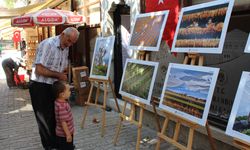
[2,58,25,89]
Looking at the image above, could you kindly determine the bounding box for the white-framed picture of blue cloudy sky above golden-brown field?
[159,63,219,126]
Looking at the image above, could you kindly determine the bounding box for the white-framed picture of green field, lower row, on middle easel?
[119,59,158,105]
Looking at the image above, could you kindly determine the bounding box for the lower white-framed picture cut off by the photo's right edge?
[226,71,250,143]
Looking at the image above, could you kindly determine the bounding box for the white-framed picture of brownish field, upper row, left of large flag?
[128,10,169,51]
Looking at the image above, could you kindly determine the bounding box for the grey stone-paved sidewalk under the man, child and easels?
[0,79,178,150]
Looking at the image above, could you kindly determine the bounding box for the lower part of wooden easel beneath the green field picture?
[114,96,146,150]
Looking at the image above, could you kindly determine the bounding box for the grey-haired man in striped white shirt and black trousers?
[29,27,79,150]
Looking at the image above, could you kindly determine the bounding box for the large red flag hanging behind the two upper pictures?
[146,0,180,51]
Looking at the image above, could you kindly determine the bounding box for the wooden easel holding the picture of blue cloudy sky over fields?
[156,53,216,150]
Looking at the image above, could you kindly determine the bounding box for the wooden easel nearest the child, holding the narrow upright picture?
[81,78,120,137]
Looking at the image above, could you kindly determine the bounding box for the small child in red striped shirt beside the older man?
[53,81,74,150]
